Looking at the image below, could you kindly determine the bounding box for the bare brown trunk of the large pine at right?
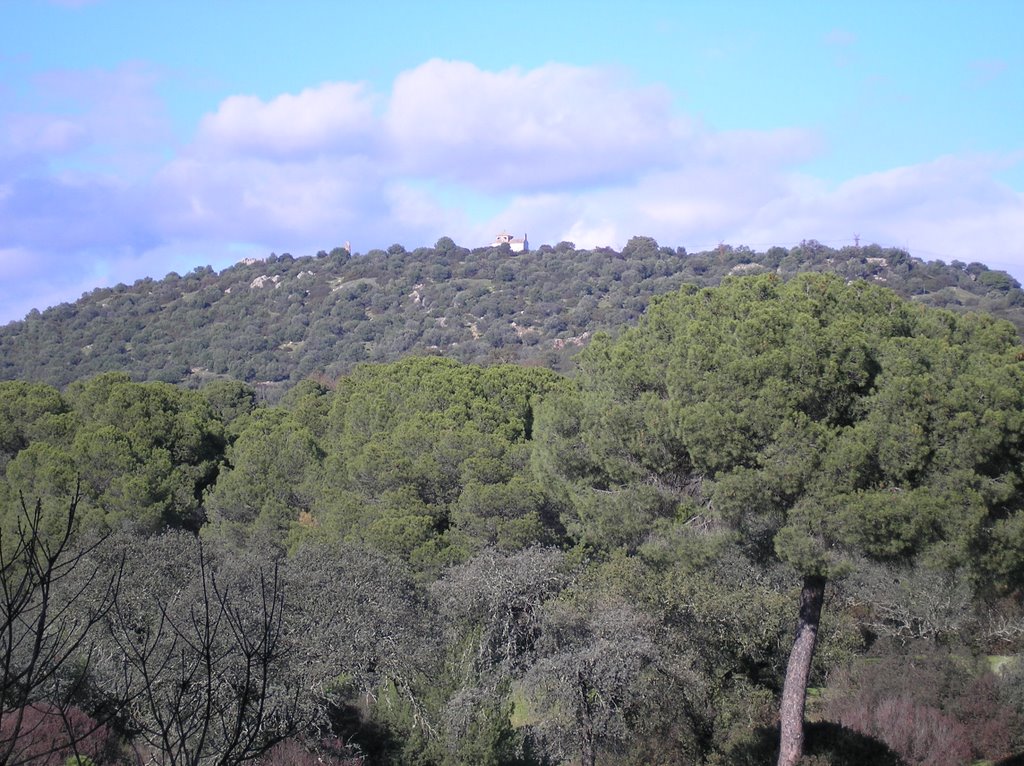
[778,575,825,766]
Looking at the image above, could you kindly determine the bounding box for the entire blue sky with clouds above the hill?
[0,0,1024,323]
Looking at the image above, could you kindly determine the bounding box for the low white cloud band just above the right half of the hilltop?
[468,153,1024,268]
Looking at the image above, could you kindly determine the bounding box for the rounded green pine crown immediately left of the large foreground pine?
[315,357,559,569]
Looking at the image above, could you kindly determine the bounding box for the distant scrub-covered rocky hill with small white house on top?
[0,237,1024,387]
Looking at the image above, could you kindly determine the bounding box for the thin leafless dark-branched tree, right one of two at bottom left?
[104,536,300,766]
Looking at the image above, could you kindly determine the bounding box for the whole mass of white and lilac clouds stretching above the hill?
[0,59,1024,321]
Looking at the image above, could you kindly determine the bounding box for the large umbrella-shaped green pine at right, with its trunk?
[538,275,1024,764]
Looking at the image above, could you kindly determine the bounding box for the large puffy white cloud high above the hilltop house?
[385,59,686,190]
